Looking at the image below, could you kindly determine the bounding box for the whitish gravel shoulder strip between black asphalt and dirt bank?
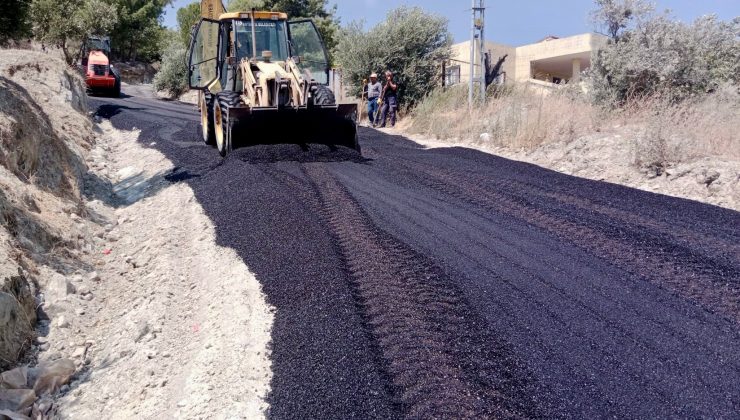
[54,122,273,419]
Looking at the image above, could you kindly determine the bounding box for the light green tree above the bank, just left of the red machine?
[31,0,117,64]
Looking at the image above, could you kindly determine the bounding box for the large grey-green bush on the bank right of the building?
[587,0,740,104]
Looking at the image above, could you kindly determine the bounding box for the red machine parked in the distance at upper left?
[81,36,121,98]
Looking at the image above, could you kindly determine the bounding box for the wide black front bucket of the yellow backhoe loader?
[227,104,359,151]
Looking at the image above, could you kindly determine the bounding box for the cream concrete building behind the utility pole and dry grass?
[445,34,607,85]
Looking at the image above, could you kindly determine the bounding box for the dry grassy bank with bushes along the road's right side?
[404,0,740,209]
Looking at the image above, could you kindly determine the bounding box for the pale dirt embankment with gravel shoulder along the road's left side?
[0,50,273,418]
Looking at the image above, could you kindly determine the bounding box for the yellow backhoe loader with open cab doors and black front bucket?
[188,0,360,156]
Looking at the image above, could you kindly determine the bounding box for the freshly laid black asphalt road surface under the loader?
[91,90,740,419]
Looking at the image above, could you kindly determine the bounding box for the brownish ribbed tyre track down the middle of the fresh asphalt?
[269,164,544,418]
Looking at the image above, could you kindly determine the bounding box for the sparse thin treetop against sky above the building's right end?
[591,0,655,42]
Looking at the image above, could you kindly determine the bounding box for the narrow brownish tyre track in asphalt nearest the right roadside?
[388,156,740,323]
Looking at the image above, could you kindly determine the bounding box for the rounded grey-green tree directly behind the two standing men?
[335,7,452,106]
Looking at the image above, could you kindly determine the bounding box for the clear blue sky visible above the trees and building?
[164,0,740,46]
